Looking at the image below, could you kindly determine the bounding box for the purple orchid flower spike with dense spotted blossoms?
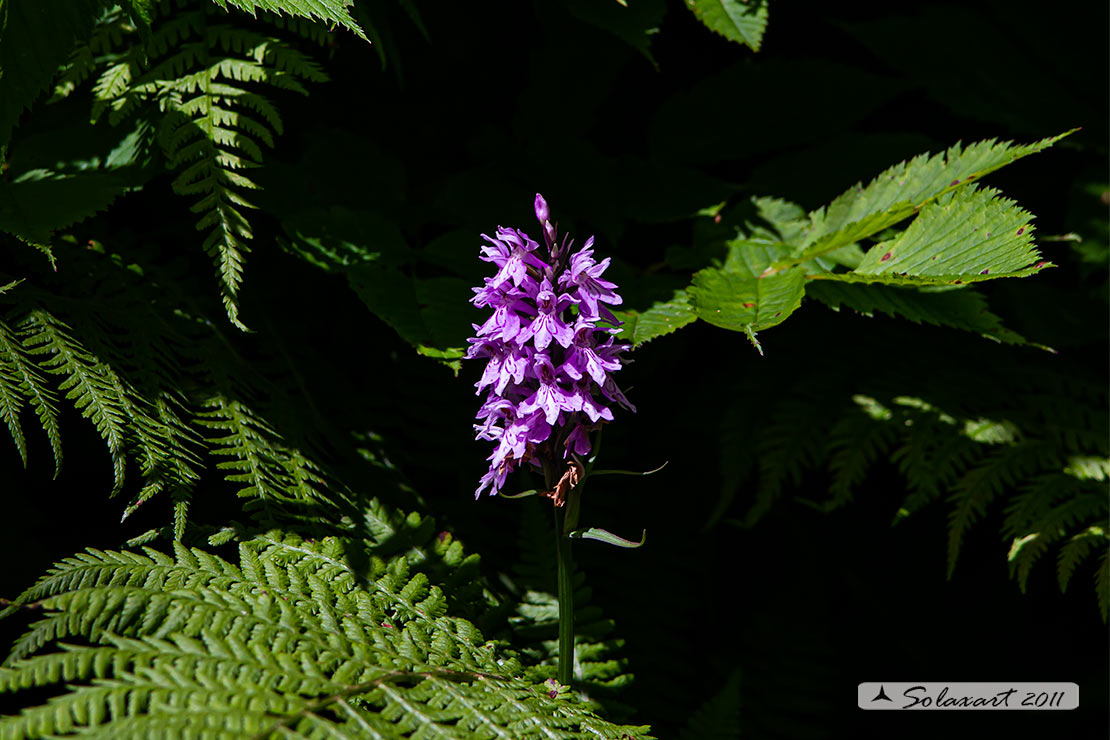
[466,194,636,506]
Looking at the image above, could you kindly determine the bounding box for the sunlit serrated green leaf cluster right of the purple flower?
[648,134,1067,353]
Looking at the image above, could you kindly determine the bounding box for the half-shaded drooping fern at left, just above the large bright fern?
[0,241,377,532]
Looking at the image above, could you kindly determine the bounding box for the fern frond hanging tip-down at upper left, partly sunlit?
[78,5,330,330]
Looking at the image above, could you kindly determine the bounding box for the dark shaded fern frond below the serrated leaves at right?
[718,343,1110,608]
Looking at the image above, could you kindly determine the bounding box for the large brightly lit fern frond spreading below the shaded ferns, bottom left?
[0,530,648,740]
